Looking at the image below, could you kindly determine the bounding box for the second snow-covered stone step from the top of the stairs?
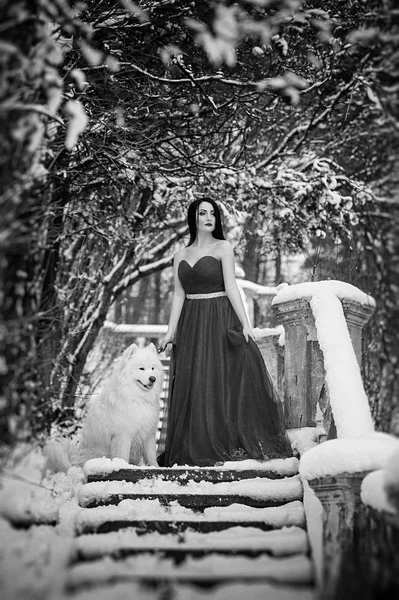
[78,475,303,510]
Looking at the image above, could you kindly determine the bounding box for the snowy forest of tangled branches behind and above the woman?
[0,0,399,455]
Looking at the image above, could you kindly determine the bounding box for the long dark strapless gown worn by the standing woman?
[159,256,292,466]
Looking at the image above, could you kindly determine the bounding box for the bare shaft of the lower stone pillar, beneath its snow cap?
[309,472,367,600]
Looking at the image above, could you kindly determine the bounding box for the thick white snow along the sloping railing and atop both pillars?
[272,281,399,488]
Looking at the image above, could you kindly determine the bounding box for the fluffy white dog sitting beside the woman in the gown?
[44,344,163,471]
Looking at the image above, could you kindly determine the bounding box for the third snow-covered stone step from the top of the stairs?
[75,500,305,535]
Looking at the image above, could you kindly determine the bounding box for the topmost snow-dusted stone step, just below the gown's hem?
[84,457,299,482]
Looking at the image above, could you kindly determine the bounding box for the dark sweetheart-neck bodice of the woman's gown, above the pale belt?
[177,255,224,294]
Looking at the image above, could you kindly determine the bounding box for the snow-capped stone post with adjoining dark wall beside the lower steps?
[299,432,399,600]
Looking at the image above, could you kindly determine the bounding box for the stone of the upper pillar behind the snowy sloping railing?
[273,298,374,429]
